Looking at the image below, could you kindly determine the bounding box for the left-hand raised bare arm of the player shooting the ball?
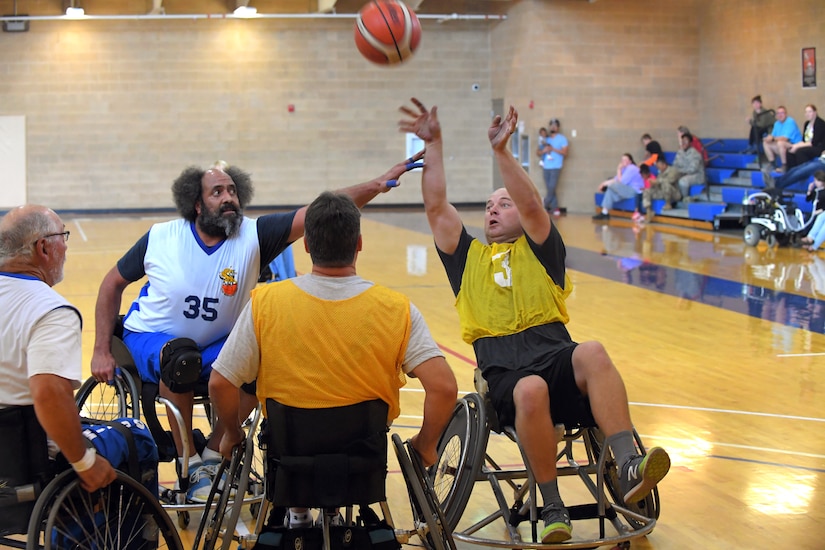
[398,98,463,254]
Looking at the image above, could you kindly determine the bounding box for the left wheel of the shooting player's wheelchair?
[428,393,489,531]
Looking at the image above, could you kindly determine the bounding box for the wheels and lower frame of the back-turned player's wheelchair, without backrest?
[198,407,455,550]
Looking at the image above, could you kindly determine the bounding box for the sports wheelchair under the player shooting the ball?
[428,369,660,549]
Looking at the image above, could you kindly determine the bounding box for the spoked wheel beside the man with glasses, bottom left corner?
[26,470,183,550]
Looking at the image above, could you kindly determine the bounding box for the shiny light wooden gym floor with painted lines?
[57,208,825,550]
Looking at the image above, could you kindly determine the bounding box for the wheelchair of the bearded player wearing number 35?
[75,322,263,529]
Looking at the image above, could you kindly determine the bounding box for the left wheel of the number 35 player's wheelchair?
[75,369,140,420]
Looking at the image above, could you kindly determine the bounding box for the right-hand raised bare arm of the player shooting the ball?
[486,105,550,244]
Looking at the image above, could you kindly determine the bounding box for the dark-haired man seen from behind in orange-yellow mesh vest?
[209,192,457,526]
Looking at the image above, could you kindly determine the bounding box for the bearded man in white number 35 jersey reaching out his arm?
[92,157,418,502]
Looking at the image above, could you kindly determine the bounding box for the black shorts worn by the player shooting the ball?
[482,343,596,428]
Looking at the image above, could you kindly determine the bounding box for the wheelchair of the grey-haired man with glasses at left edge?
[0,406,183,550]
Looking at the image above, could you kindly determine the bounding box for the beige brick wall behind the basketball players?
[0,0,825,212]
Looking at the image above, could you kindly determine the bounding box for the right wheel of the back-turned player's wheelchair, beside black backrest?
[392,434,455,550]
